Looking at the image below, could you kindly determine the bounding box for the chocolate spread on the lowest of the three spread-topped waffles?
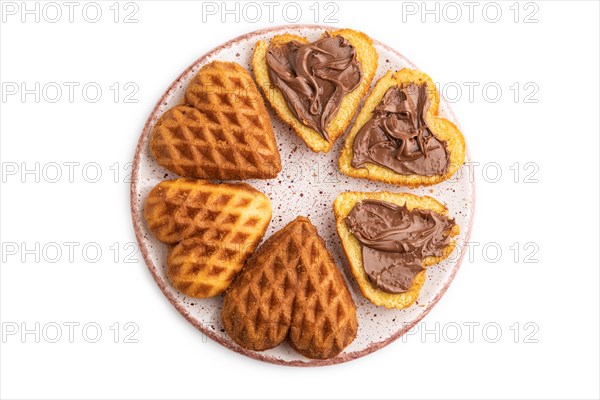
[346,200,454,293]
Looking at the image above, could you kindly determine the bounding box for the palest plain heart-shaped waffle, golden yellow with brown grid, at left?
[144,178,271,297]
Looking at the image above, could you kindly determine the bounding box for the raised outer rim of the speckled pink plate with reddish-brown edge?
[130,24,476,367]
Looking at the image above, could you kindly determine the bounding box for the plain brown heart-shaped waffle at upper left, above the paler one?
[150,61,281,180]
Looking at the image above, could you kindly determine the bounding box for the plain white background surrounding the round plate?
[0,1,600,399]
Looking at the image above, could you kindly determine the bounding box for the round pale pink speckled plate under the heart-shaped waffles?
[131,25,475,366]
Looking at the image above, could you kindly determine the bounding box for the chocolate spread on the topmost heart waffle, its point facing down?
[267,34,362,141]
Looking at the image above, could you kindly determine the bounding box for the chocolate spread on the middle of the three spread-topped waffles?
[351,83,450,176]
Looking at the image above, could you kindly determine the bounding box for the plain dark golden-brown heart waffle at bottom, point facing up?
[221,217,358,358]
